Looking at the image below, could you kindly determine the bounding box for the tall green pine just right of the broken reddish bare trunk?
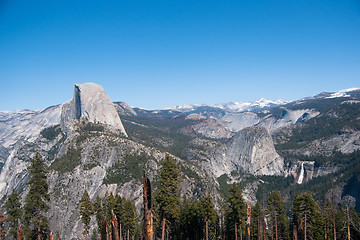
[155,155,180,240]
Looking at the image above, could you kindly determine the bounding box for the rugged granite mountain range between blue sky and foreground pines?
[0,84,360,239]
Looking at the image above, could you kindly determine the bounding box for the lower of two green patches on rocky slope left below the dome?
[50,146,81,173]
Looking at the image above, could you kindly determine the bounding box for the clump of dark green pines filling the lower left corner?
[0,153,50,240]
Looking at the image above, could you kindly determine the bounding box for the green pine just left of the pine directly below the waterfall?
[267,191,289,240]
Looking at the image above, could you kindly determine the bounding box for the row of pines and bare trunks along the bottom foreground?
[0,154,360,240]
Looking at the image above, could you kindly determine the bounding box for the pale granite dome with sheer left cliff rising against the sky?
[61,83,127,136]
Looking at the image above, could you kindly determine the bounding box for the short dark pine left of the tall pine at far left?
[4,189,22,239]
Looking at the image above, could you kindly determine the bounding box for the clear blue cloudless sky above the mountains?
[0,0,360,110]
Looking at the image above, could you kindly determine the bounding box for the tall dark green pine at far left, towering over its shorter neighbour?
[24,153,50,240]
